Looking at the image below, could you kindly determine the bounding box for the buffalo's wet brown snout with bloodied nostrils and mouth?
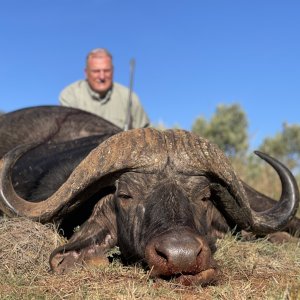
[145,229,216,285]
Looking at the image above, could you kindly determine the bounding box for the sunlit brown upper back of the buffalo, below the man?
[0,106,121,157]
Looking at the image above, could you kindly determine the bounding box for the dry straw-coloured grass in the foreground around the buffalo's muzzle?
[0,218,300,300]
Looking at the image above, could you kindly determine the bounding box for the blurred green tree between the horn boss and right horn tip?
[192,104,248,156]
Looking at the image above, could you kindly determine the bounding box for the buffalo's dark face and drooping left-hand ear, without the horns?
[50,173,225,284]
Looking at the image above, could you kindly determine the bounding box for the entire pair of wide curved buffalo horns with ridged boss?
[0,128,299,233]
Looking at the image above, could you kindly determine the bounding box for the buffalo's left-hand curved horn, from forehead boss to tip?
[0,129,167,222]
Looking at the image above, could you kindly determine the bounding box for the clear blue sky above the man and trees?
[0,0,300,149]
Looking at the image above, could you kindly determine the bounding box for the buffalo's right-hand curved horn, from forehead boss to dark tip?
[165,131,300,234]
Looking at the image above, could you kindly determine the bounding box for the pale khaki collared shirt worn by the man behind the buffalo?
[59,80,150,129]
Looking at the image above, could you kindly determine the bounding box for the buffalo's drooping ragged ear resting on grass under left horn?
[49,195,117,273]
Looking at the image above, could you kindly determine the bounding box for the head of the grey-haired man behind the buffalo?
[85,48,113,97]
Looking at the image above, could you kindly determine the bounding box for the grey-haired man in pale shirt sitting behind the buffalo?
[59,48,150,129]
